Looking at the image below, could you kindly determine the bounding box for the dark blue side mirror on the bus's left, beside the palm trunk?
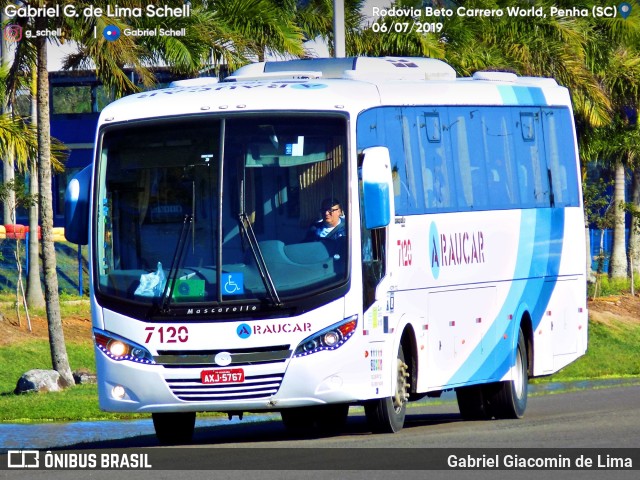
[64,165,91,245]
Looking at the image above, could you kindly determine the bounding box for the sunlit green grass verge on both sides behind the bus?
[0,302,640,423]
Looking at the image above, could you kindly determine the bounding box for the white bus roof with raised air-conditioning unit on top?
[101,57,571,123]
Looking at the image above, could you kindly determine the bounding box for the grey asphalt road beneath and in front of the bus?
[0,386,640,480]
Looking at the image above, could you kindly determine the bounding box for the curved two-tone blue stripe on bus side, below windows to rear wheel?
[447,208,564,385]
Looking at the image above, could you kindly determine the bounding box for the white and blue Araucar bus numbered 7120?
[66,57,587,443]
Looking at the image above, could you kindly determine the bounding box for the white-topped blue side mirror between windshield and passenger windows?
[362,147,393,230]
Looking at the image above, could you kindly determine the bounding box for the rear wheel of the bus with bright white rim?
[490,330,529,418]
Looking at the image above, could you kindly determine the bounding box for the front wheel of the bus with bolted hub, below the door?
[364,346,409,433]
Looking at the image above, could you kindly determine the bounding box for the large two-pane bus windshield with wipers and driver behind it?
[94,115,349,308]
